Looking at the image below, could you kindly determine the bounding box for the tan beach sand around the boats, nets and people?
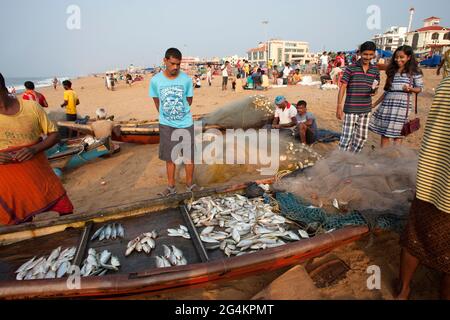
[36,70,441,299]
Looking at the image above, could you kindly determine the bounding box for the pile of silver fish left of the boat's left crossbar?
[15,247,77,280]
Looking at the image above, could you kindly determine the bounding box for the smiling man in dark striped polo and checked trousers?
[336,41,380,153]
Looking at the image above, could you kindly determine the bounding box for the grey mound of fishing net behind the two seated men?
[202,95,275,129]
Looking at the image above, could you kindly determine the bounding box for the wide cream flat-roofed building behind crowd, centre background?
[247,39,311,64]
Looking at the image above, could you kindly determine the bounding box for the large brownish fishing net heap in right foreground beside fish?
[276,147,418,229]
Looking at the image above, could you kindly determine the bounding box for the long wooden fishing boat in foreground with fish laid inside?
[0,179,368,299]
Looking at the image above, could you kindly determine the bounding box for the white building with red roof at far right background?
[405,17,450,53]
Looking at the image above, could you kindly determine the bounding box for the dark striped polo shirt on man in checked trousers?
[341,60,380,114]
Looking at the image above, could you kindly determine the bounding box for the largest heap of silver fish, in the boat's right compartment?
[190,194,308,257]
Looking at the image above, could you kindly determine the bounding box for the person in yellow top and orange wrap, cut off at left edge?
[0,74,73,225]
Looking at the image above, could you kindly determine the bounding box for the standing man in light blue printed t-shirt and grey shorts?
[150,48,199,196]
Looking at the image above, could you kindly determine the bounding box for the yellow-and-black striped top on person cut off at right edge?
[416,76,450,214]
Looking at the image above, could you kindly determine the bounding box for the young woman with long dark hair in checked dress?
[369,46,423,148]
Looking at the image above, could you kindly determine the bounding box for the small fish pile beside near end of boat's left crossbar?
[80,248,120,277]
